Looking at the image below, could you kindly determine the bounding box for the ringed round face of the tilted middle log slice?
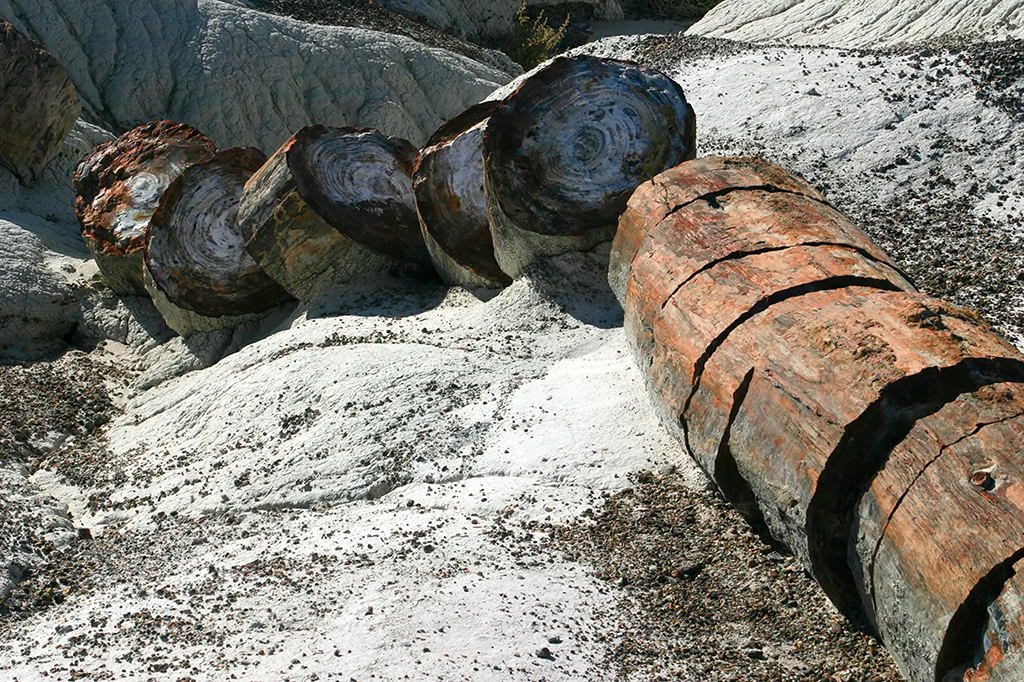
[286,125,430,263]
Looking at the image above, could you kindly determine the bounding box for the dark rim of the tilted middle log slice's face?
[286,124,430,263]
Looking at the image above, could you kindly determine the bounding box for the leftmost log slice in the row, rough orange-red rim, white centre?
[74,121,216,296]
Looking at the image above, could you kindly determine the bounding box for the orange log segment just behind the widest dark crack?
[682,287,1024,573]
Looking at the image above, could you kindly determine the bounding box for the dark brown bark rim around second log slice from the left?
[145,147,292,317]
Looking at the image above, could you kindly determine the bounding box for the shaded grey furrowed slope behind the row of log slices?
[0,0,509,148]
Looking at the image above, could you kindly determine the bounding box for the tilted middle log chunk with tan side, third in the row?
[239,125,429,300]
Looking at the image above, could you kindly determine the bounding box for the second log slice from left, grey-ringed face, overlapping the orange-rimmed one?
[145,147,289,336]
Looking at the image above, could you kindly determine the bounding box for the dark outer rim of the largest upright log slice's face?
[483,55,695,237]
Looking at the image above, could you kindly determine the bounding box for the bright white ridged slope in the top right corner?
[686,0,1024,47]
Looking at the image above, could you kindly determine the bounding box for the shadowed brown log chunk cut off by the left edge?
[0,20,82,183]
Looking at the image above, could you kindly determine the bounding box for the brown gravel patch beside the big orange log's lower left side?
[516,472,903,682]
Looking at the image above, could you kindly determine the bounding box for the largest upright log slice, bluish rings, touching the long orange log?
[483,56,696,276]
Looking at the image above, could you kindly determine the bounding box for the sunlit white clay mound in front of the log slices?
[0,253,705,680]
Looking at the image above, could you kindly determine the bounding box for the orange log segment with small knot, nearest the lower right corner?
[851,383,1024,679]
